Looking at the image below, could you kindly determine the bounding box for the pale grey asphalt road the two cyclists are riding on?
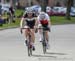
[0,24,75,61]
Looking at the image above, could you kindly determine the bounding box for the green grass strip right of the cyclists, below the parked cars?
[51,16,75,25]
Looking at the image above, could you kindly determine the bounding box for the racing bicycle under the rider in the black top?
[22,28,32,56]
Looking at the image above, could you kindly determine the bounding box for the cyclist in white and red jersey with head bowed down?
[37,12,50,48]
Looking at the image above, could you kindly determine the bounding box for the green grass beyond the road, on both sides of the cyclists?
[0,14,75,29]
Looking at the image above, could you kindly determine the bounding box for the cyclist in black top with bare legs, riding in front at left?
[20,8,37,50]
